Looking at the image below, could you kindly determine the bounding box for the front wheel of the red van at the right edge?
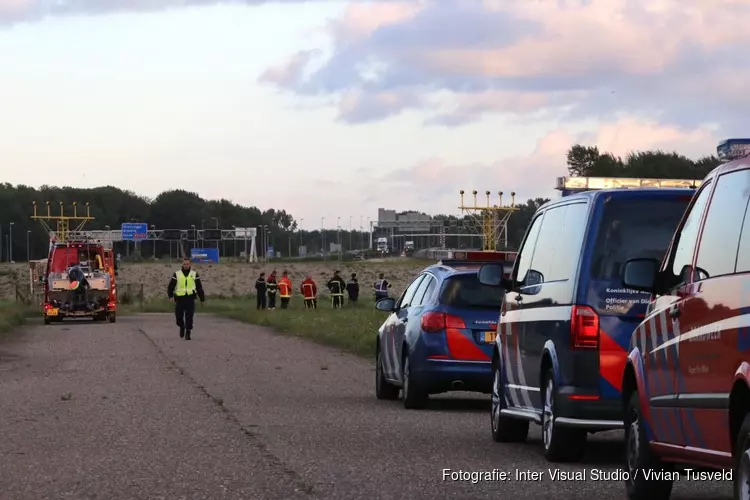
[624,392,672,500]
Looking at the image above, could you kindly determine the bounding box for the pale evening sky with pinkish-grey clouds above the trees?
[0,0,750,228]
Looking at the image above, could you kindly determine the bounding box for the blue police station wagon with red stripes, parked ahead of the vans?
[375,251,516,409]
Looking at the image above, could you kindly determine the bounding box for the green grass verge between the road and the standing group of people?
[119,296,387,357]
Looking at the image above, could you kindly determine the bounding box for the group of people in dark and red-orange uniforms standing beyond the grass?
[255,269,391,310]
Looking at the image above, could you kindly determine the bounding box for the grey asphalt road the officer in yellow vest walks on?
[0,315,731,500]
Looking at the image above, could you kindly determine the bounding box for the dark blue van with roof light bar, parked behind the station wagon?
[479,178,700,462]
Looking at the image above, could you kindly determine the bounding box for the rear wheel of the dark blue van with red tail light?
[542,369,587,462]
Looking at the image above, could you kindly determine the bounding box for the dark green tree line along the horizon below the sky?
[0,145,721,261]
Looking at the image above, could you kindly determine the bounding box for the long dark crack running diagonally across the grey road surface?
[138,328,317,496]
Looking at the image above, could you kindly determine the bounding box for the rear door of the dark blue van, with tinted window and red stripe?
[581,189,692,398]
